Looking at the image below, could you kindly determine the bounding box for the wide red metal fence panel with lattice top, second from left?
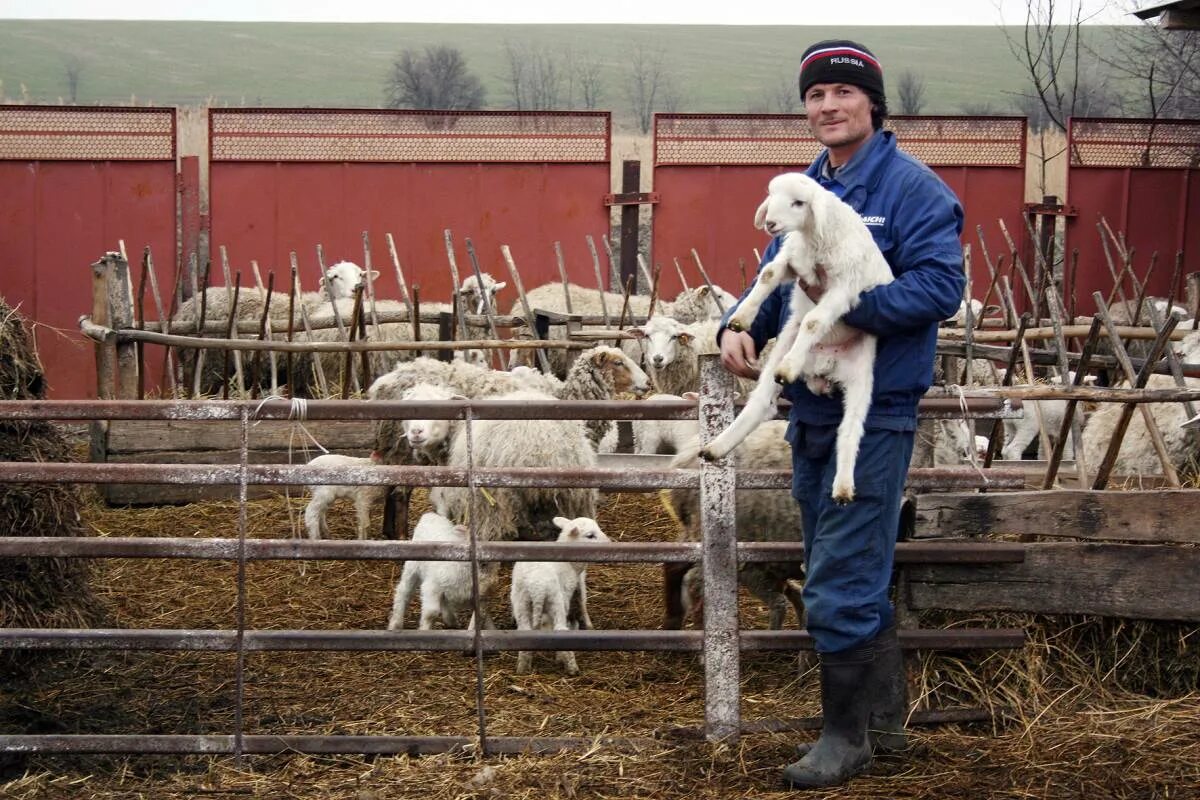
[209,109,611,311]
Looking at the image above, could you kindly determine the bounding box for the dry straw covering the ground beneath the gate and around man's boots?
[0,491,1200,800]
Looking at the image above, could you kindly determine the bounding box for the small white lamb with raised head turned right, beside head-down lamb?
[510,517,610,675]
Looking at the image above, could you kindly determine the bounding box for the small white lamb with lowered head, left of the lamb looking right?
[388,512,497,631]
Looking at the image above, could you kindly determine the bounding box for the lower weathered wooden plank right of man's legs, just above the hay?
[906,542,1200,621]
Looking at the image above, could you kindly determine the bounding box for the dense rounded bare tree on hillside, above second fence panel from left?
[384,46,484,110]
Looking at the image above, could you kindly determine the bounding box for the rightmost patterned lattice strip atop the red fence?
[1069,119,1200,169]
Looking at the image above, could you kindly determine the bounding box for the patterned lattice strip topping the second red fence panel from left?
[209,109,611,163]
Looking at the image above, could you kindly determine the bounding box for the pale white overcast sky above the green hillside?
[0,0,1137,25]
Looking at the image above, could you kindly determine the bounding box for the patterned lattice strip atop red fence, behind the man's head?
[654,114,1025,168]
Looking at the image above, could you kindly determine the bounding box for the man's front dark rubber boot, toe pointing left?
[784,642,874,789]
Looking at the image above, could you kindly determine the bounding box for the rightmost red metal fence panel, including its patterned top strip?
[1064,119,1200,314]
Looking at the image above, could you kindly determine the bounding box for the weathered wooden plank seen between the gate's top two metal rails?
[108,420,374,453]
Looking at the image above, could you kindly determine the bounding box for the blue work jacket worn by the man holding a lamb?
[718,131,966,431]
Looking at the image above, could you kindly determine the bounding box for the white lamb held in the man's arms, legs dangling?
[701,173,893,504]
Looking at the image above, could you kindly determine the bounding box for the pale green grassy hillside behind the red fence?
[0,19,1123,128]
